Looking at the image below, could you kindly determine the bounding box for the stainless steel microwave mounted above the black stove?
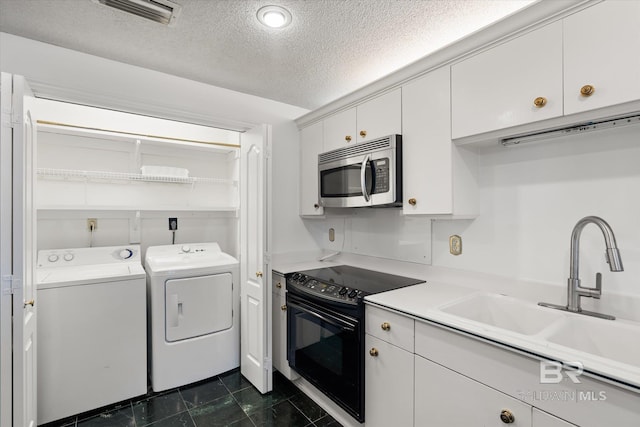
[318,135,402,208]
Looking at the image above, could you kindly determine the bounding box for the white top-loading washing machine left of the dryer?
[37,245,147,424]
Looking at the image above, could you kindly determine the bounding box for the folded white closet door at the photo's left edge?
[0,73,37,427]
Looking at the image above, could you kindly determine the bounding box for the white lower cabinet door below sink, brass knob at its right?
[412,356,531,427]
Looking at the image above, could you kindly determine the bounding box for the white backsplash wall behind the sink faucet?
[433,126,640,299]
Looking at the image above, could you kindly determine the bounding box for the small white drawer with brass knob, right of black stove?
[365,305,414,353]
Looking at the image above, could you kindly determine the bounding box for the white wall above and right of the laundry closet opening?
[0,33,316,258]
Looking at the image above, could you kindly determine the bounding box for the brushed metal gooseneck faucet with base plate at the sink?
[538,216,624,320]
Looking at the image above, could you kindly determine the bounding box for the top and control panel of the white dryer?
[145,243,238,276]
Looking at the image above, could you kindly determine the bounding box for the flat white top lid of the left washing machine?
[36,263,146,290]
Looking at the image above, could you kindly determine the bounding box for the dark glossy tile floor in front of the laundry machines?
[40,369,341,427]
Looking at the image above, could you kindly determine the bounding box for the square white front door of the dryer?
[165,273,233,342]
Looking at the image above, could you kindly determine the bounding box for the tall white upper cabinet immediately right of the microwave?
[402,67,478,216]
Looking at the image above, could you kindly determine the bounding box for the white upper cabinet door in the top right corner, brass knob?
[563,0,640,114]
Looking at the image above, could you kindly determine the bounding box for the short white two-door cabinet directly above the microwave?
[324,88,402,151]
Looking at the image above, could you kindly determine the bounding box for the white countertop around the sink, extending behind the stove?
[272,253,640,393]
